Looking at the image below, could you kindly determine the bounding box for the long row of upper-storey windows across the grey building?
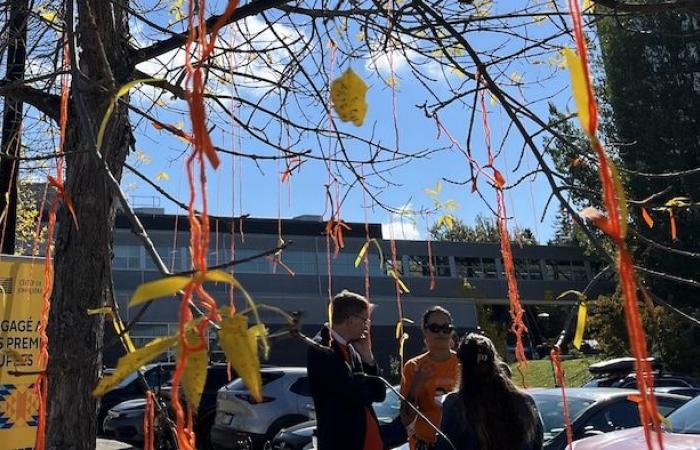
[112,245,597,281]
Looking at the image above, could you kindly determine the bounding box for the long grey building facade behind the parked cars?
[105,210,610,367]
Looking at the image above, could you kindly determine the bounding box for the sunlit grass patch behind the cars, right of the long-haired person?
[510,358,599,388]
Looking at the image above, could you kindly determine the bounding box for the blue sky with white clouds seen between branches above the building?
[123,1,571,242]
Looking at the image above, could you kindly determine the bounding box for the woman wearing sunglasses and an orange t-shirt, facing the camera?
[401,306,460,450]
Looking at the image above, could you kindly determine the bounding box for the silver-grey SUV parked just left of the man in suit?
[211,367,314,449]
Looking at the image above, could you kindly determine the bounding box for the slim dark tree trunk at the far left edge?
[0,0,29,255]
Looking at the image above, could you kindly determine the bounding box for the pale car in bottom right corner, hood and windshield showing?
[573,397,700,450]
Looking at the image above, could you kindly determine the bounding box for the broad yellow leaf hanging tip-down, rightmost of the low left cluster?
[219,314,262,401]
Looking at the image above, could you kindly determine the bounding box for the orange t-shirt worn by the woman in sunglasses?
[401,352,460,449]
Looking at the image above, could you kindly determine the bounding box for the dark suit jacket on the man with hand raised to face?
[307,327,386,450]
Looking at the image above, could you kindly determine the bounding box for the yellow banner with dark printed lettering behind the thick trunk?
[0,255,44,450]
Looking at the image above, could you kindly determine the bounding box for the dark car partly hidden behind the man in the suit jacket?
[270,386,408,450]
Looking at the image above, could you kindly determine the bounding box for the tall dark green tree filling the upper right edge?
[598,7,700,305]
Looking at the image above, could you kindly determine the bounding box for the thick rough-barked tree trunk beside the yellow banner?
[46,0,131,450]
